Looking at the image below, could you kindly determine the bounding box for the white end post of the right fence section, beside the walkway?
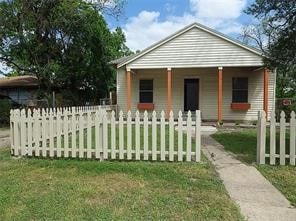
[257,111,266,164]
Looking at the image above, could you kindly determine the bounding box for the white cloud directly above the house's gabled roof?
[123,0,247,51]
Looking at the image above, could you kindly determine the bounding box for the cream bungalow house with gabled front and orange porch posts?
[112,23,276,121]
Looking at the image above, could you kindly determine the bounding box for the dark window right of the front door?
[232,78,248,103]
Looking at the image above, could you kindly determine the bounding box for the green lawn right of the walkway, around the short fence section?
[212,129,296,206]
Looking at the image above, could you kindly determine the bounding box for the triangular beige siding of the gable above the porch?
[127,27,263,69]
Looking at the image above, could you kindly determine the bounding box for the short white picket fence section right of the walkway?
[257,111,296,166]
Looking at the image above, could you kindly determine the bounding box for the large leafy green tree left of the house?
[0,0,130,105]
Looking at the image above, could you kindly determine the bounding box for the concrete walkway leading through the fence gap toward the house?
[202,135,296,221]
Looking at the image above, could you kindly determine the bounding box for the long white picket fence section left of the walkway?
[10,108,200,162]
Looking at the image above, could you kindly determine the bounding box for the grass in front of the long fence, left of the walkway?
[0,148,242,220]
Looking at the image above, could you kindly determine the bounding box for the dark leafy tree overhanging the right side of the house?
[243,0,296,99]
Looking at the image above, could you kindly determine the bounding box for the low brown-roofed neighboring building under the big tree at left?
[0,75,40,106]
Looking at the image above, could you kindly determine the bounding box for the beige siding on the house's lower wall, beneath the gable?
[117,68,275,120]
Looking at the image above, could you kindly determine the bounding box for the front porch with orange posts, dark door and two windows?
[121,67,271,122]
